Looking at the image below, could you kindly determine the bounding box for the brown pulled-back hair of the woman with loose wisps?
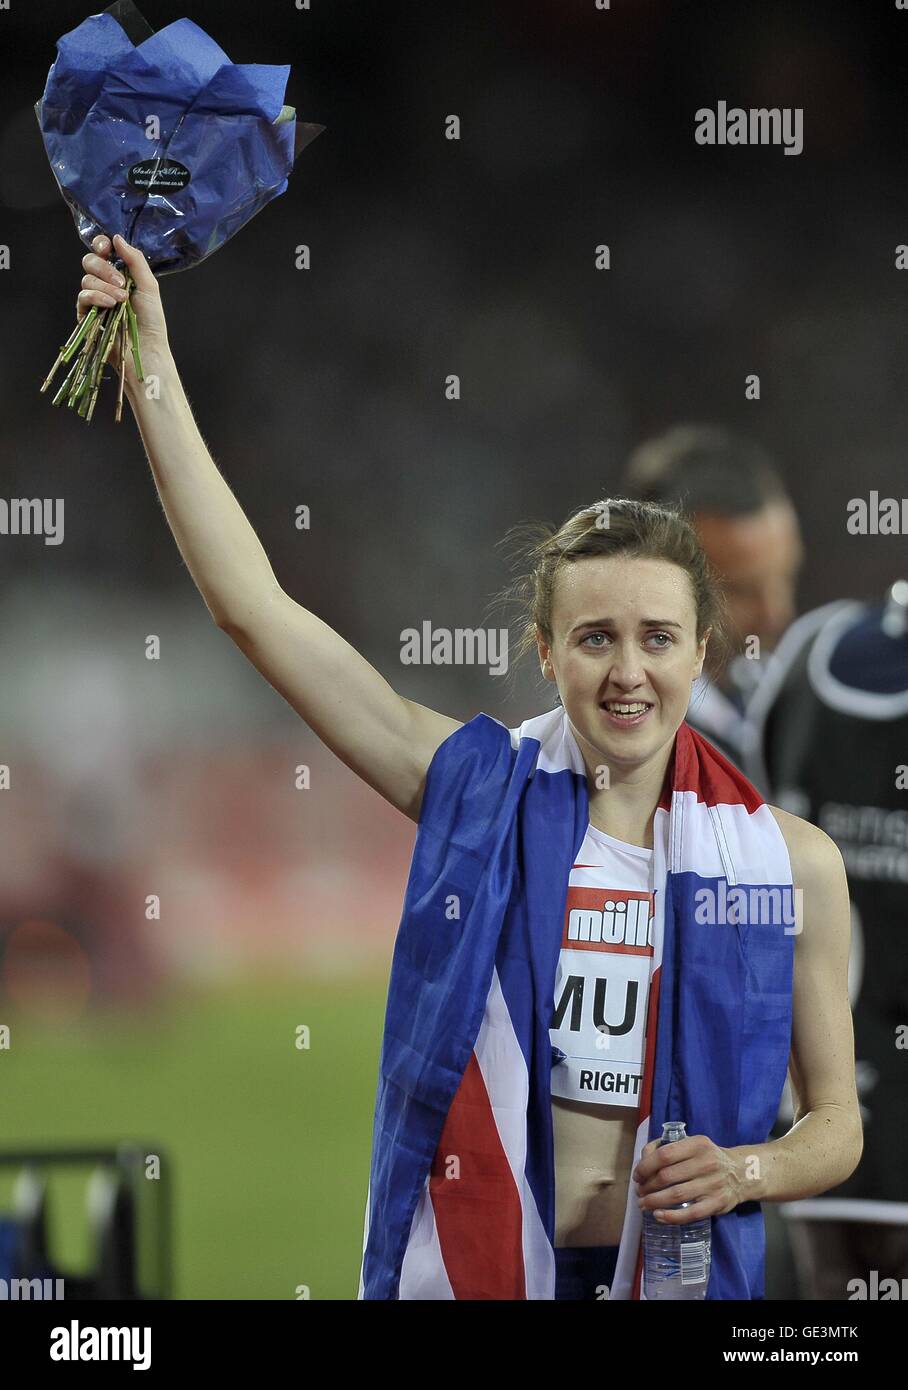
[494,498,727,695]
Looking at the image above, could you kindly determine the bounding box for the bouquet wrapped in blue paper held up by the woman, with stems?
[35,0,324,420]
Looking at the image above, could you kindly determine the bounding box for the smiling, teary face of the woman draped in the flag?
[537,555,709,769]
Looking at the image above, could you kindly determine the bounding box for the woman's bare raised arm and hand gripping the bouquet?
[78,238,462,820]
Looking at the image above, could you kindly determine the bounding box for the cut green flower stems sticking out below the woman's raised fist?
[40,271,145,424]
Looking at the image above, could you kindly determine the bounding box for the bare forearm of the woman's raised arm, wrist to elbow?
[127,352,278,623]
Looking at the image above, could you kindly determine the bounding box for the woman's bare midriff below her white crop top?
[552,1097,640,1245]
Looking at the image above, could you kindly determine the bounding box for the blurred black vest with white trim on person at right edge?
[744,580,908,1300]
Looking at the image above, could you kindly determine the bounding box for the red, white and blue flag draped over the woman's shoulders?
[359,706,797,1300]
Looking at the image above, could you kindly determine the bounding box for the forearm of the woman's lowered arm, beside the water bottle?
[729,1105,862,1202]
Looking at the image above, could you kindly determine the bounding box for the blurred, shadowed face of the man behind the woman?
[695,502,804,655]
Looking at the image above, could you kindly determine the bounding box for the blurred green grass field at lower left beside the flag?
[0,977,387,1298]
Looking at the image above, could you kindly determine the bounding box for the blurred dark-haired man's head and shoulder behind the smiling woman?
[624,425,804,766]
